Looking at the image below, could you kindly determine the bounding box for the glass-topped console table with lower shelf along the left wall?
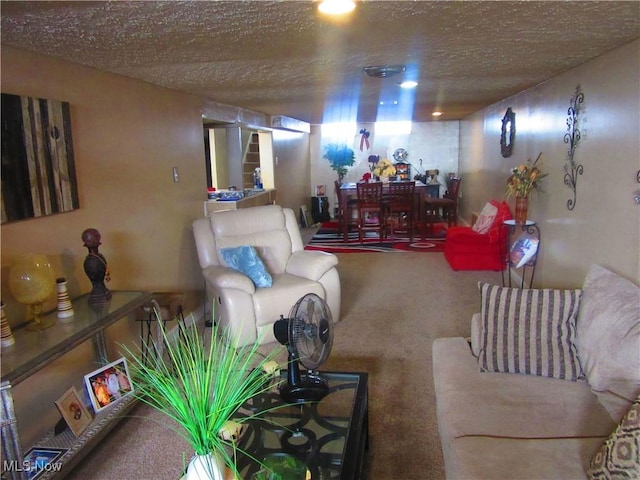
[0,291,153,480]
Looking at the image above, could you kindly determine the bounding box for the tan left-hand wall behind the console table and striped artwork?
[1,46,207,320]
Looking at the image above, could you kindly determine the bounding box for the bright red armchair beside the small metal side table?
[444,200,513,271]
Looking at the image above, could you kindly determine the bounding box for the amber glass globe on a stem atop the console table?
[9,253,56,330]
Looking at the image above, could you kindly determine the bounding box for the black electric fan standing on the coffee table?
[273,293,333,403]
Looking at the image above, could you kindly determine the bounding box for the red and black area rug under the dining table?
[305,222,447,253]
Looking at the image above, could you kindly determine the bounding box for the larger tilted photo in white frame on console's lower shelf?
[84,357,133,413]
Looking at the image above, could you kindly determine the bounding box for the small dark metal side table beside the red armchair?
[502,220,540,288]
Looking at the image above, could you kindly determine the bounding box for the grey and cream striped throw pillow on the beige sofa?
[478,282,584,380]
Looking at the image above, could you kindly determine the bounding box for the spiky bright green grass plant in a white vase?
[122,311,280,479]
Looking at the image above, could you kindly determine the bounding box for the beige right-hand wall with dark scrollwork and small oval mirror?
[460,41,640,287]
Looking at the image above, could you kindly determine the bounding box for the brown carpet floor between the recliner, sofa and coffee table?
[67,252,501,480]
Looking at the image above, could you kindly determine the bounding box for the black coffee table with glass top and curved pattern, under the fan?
[232,372,369,480]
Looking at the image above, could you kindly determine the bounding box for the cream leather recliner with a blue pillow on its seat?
[193,205,340,346]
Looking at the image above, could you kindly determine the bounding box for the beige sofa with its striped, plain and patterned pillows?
[433,265,640,480]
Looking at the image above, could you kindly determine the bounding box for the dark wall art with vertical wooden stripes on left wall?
[2,93,80,223]
